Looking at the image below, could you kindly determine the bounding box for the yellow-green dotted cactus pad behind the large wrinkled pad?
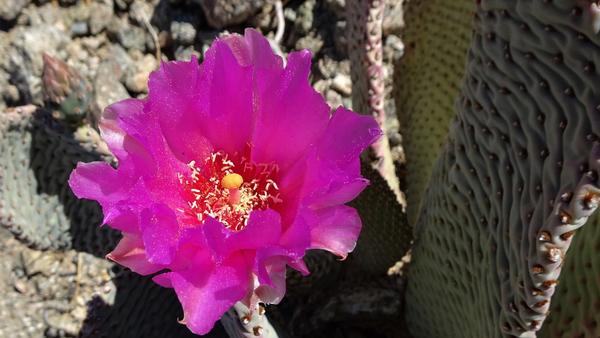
[394,0,475,224]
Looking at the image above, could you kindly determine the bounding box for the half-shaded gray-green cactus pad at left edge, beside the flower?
[0,106,117,255]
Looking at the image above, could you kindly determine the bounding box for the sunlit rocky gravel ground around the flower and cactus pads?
[0,0,403,337]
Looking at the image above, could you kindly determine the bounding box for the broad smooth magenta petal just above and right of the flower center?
[252,50,329,171]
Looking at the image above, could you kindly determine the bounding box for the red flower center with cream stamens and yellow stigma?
[178,152,281,231]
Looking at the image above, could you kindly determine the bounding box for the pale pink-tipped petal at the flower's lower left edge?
[106,233,164,275]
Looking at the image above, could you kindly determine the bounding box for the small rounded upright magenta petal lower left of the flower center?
[140,204,179,265]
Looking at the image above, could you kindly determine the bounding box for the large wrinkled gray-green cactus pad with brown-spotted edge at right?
[407,0,600,338]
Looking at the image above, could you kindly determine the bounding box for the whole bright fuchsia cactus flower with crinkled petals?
[69,30,381,334]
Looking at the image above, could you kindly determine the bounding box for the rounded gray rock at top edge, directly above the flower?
[194,0,265,29]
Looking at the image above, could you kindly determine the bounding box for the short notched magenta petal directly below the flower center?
[203,209,281,261]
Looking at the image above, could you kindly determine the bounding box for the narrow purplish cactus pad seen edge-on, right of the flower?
[346,0,405,206]
